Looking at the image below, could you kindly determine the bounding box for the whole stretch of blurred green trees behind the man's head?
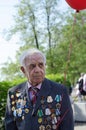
[1,0,86,88]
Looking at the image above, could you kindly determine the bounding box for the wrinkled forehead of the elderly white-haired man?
[25,53,44,63]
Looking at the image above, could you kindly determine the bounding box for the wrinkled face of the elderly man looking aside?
[23,53,45,86]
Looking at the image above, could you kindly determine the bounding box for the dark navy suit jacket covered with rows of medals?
[5,79,74,130]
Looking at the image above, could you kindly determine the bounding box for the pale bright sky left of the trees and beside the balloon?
[0,0,68,68]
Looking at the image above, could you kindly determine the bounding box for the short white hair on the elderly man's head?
[20,48,46,66]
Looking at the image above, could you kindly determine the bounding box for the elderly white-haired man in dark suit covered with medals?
[5,49,74,130]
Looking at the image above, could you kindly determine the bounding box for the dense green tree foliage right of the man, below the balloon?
[47,11,86,84]
